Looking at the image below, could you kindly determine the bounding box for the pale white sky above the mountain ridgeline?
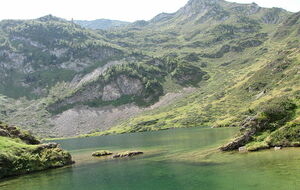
[0,0,300,22]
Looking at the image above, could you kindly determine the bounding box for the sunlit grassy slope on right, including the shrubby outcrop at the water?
[98,10,300,150]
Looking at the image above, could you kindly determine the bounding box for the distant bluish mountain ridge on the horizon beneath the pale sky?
[74,19,130,30]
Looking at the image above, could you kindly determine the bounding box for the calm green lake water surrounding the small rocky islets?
[0,128,300,190]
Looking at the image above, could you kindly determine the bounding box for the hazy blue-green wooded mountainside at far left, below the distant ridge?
[0,15,124,98]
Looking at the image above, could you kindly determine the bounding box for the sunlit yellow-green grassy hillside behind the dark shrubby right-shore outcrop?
[84,10,300,149]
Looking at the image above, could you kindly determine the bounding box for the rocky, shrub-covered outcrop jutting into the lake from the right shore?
[219,97,300,152]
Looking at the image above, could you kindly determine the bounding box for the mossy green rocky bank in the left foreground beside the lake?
[0,123,73,178]
